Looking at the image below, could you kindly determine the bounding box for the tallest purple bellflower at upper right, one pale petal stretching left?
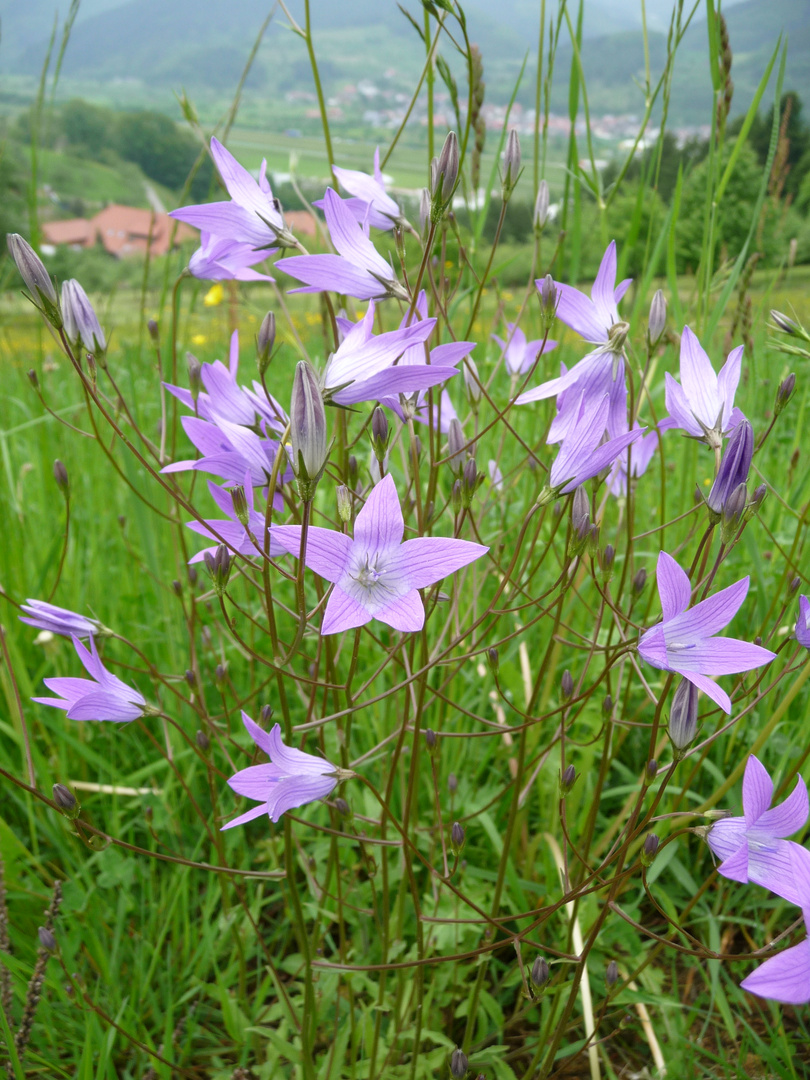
[515,241,631,405]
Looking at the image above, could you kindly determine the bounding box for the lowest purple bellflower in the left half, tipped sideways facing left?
[222,712,353,831]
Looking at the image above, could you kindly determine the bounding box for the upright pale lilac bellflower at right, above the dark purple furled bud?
[665,326,743,447]
